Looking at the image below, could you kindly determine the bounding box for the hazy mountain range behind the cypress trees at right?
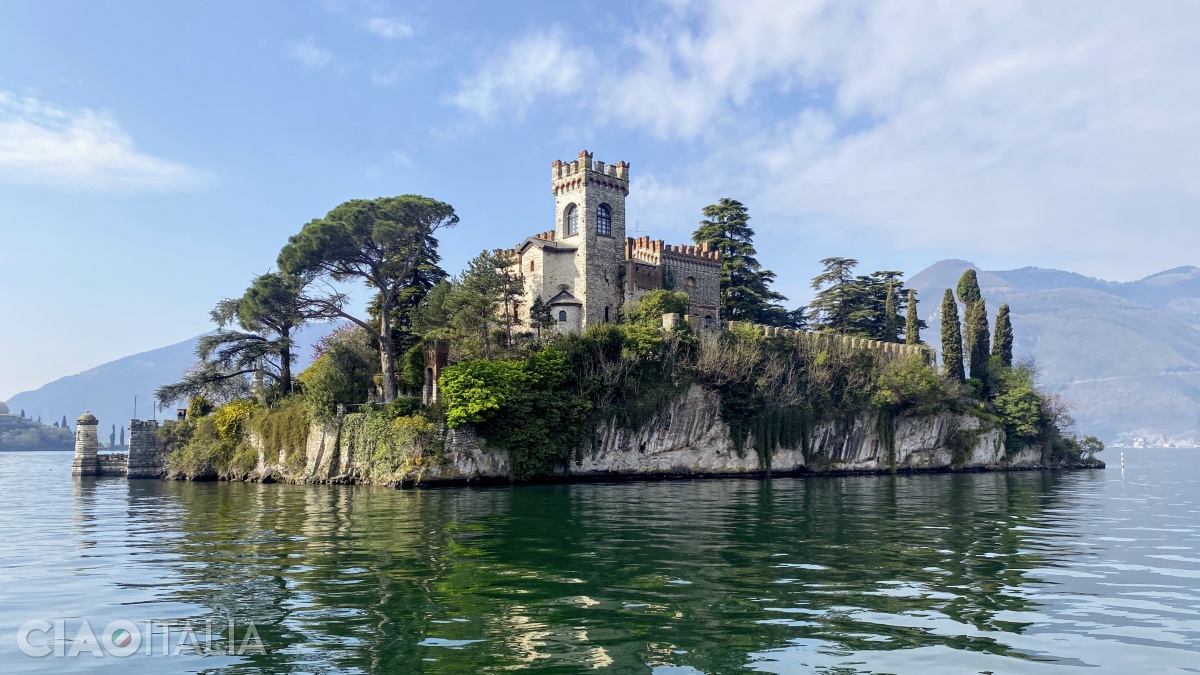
[908,261,1200,442]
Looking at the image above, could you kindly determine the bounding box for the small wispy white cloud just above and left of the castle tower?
[449,28,593,121]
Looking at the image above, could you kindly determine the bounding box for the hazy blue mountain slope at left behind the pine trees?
[7,323,332,432]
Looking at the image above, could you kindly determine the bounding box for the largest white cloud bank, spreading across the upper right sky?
[455,0,1200,277]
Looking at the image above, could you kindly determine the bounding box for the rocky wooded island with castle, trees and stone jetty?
[68,151,1104,485]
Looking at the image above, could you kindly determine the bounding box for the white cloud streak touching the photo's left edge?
[0,91,208,190]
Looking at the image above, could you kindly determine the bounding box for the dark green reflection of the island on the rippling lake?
[131,472,1099,673]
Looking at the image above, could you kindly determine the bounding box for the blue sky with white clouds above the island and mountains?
[0,0,1200,400]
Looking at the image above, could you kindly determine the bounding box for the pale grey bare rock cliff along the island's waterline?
[256,386,1080,484]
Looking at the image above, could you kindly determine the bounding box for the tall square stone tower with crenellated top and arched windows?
[551,150,629,328]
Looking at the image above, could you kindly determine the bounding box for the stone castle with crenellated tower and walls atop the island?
[514,150,721,333]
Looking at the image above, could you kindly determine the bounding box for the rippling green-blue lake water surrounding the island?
[0,449,1200,675]
